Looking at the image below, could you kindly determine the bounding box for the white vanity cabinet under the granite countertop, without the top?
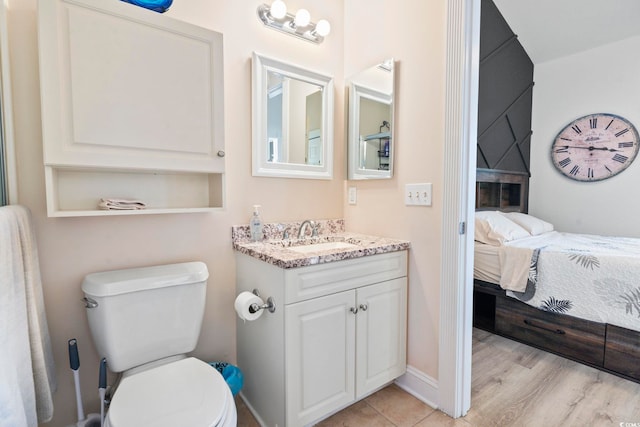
[237,251,407,427]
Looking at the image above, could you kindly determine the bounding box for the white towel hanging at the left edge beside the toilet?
[0,206,56,427]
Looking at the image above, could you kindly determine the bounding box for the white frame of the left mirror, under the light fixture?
[251,52,334,179]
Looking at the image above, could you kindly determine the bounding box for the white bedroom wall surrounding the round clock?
[529,37,640,237]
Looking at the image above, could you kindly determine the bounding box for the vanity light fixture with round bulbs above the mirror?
[258,0,331,43]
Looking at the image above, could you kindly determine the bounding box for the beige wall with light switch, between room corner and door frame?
[344,0,446,378]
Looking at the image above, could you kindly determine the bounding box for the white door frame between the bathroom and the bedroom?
[438,0,480,418]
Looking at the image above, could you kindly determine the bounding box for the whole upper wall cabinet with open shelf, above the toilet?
[38,0,225,216]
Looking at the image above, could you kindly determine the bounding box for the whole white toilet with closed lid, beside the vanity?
[82,262,237,427]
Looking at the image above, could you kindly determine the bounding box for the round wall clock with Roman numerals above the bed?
[551,113,640,182]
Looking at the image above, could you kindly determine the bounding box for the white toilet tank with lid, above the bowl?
[82,262,209,372]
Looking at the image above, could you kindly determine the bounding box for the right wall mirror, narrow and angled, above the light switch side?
[347,58,395,179]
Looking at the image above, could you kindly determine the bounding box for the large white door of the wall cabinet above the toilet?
[38,0,224,172]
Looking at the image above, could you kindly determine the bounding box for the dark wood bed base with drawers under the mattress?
[473,280,640,383]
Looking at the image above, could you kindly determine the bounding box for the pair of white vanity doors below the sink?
[285,278,406,425]
